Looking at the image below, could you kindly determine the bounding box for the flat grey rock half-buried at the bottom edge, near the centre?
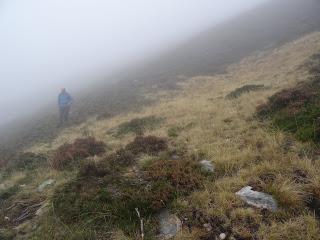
[158,210,182,240]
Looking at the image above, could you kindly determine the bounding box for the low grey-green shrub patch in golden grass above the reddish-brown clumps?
[116,116,164,136]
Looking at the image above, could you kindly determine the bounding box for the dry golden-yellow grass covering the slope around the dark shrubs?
[0,33,320,240]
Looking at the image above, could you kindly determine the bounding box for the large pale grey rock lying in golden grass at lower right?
[236,186,278,212]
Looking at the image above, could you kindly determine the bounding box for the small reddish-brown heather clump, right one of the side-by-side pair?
[126,136,168,155]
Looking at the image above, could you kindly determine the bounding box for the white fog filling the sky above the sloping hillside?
[0,0,265,124]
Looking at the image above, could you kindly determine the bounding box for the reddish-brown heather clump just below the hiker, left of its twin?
[50,137,105,170]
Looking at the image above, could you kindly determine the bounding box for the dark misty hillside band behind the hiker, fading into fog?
[0,0,320,153]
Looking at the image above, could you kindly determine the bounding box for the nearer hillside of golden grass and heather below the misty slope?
[0,32,320,240]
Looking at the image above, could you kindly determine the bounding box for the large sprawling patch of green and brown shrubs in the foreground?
[53,136,209,239]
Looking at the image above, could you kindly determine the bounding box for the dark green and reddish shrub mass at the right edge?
[258,79,320,144]
